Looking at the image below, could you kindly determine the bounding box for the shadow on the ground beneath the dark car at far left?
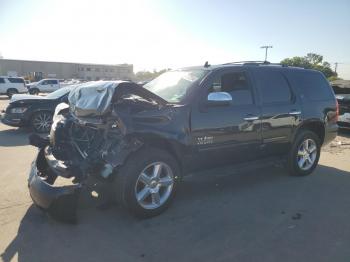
[0,127,31,147]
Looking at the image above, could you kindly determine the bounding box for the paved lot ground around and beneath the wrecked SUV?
[0,97,350,262]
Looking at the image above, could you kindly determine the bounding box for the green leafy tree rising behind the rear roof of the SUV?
[281,53,337,78]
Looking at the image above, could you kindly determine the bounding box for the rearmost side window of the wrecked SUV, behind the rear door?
[289,71,333,101]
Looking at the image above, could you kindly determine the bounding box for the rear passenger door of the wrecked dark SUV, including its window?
[253,67,302,156]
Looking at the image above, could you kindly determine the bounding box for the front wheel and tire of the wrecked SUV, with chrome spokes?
[114,148,180,218]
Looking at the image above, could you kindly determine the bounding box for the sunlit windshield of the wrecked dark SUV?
[143,69,207,103]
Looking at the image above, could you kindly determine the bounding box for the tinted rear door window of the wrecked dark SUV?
[254,70,292,104]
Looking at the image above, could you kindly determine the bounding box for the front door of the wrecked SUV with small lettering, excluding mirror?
[191,69,261,168]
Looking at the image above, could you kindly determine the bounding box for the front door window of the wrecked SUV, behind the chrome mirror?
[210,72,253,105]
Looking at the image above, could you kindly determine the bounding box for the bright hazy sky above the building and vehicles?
[0,0,350,79]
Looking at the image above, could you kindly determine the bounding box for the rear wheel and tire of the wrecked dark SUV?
[287,130,321,176]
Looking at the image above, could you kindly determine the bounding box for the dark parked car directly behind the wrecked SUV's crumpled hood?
[2,87,71,133]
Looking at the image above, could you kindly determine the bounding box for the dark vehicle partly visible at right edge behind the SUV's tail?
[332,83,350,129]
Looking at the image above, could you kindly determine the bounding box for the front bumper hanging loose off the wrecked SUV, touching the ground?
[28,148,81,223]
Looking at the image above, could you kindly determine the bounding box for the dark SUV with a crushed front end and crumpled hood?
[28,62,338,222]
